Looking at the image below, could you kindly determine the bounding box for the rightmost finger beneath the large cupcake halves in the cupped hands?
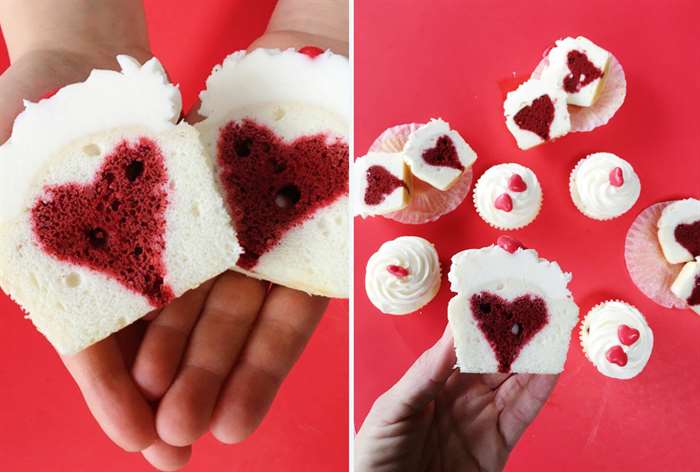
[211,287,328,444]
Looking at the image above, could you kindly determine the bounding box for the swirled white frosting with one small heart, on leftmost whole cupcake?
[365,236,441,315]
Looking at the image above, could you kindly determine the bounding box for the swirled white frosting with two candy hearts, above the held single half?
[474,163,542,229]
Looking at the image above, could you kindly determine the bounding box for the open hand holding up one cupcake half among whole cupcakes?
[355,329,558,472]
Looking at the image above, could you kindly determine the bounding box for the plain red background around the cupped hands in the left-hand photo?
[0,0,349,472]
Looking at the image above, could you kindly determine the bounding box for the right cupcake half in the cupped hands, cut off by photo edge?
[196,48,351,298]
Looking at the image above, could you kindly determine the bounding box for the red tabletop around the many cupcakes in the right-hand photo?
[355,0,700,471]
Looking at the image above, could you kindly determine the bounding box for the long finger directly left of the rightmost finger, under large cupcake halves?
[156,272,266,446]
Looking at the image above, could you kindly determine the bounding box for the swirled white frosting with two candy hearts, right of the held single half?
[580,301,654,379]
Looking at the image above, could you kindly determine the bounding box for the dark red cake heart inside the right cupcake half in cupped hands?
[217,119,349,270]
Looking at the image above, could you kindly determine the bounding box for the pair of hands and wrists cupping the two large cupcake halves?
[0,0,348,470]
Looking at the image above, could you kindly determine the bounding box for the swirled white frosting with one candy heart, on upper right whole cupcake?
[569,152,642,220]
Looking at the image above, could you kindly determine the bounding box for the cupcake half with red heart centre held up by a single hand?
[448,242,578,374]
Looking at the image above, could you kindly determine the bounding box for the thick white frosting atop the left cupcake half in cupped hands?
[0,55,182,223]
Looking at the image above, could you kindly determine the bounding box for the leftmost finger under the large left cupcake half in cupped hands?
[62,337,157,452]
